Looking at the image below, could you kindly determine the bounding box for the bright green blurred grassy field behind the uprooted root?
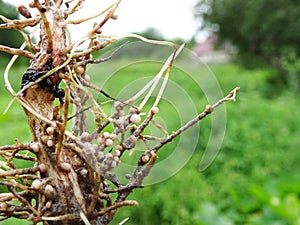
[0,60,300,225]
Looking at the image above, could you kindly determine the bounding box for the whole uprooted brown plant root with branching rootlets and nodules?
[0,0,239,225]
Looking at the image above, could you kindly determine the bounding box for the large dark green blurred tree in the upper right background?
[195,0,300,91]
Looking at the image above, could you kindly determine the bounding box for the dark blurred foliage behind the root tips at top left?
[0,0,24,61]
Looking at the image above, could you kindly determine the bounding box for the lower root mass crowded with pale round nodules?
[0,61,166,224]
